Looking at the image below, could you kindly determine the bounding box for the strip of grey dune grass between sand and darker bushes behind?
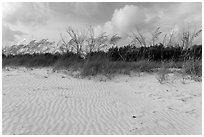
[2,55,202,79]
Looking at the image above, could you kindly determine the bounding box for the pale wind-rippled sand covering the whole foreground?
[2,68,202,135]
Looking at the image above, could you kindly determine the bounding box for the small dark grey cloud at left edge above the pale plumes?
[2,24,26,46]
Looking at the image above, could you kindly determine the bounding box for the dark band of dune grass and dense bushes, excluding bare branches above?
[2,44,202,76]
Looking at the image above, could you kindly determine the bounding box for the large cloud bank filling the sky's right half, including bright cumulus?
[97,3,202,45]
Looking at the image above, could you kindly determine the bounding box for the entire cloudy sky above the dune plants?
[2,2,202,46]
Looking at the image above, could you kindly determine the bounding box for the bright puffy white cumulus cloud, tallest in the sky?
[97,5,160,35]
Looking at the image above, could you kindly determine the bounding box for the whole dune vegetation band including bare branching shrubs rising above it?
[2,27,202,79]
